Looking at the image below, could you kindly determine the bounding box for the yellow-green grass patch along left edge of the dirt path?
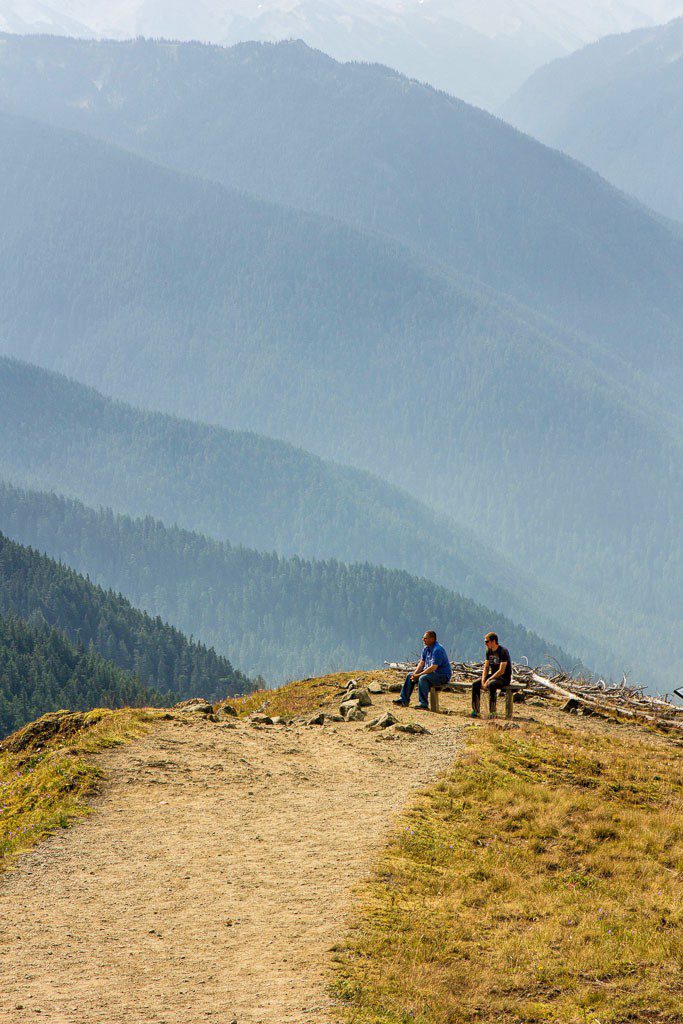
[0,709,163,873]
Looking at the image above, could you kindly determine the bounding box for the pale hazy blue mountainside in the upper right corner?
[502,18,683,220]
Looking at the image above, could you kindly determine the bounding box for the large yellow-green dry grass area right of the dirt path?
[335,723,683,1024]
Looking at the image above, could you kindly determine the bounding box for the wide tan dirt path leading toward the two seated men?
[0,697,461,1024]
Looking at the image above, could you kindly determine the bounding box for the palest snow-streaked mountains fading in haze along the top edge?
[0,0,683,106]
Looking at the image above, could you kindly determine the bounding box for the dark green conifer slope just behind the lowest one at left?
[0,534,252,698]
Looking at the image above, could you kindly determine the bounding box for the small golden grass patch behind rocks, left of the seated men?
[225,671,396,718]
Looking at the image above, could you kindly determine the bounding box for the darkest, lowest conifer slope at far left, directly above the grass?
[0,615,164,739]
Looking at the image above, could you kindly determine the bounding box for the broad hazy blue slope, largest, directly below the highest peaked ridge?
[0,118,683,679]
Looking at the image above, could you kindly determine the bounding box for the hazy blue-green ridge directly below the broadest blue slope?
[0,358,587,663]
